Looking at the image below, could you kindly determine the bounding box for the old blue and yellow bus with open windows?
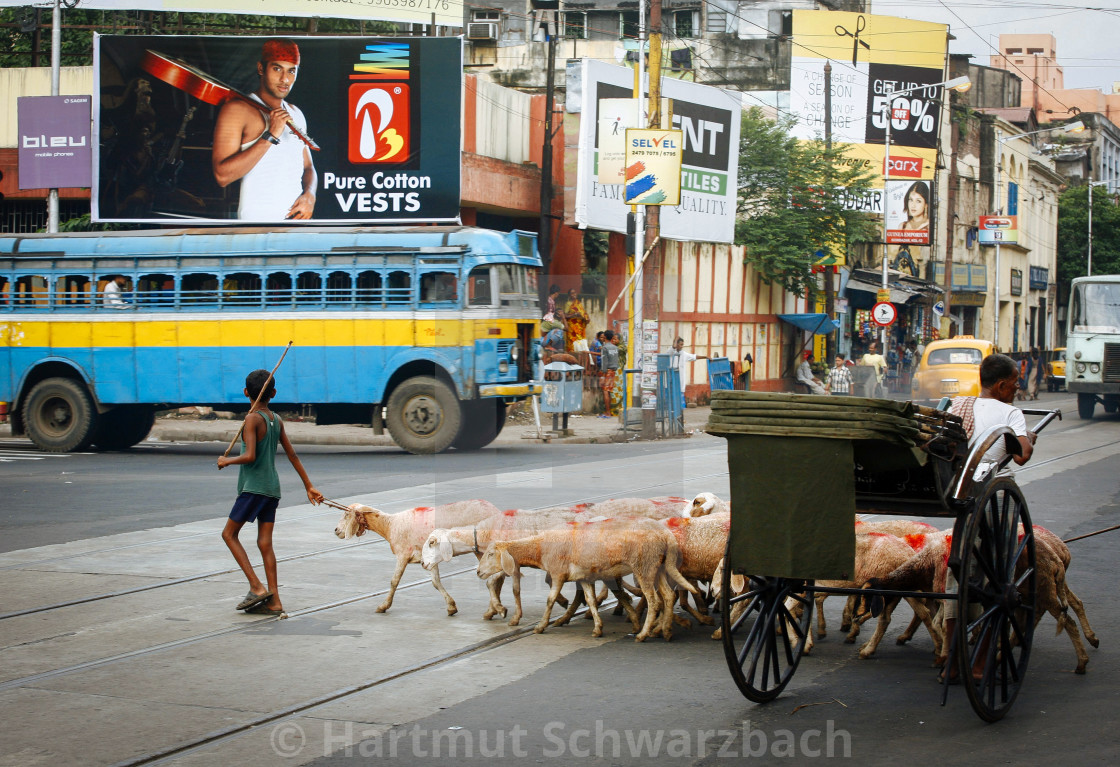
[0,226,541,453]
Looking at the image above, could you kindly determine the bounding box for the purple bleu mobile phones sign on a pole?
[16,96,93,189]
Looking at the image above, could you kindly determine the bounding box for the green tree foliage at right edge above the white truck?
[1057,185,1120,287]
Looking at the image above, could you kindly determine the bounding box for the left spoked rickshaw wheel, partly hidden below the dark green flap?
[719,537,813,703]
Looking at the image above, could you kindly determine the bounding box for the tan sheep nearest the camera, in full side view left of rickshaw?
[477,517,696,642]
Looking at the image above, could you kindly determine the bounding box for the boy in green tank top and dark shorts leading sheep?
[217,371,323,615]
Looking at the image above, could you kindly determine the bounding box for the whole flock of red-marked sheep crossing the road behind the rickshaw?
[335,493,1099,674]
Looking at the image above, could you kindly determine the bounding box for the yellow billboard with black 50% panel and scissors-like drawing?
[790,10,949,180]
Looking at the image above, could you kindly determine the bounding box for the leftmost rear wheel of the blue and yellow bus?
[24,378,97,452]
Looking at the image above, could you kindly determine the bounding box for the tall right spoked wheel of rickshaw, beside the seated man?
[956,478,1037,722]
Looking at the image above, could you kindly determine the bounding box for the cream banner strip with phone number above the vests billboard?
[20,0,463,27]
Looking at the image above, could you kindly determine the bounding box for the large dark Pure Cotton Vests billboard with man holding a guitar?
[92,35,463,224]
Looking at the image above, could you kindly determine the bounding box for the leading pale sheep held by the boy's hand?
[335,499,502,616]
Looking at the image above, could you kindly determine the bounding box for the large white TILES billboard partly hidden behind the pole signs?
[568,58,743,243]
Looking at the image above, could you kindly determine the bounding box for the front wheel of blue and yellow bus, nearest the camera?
[386,375,461,455]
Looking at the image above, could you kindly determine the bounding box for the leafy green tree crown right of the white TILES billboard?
[735,109,877,292]
